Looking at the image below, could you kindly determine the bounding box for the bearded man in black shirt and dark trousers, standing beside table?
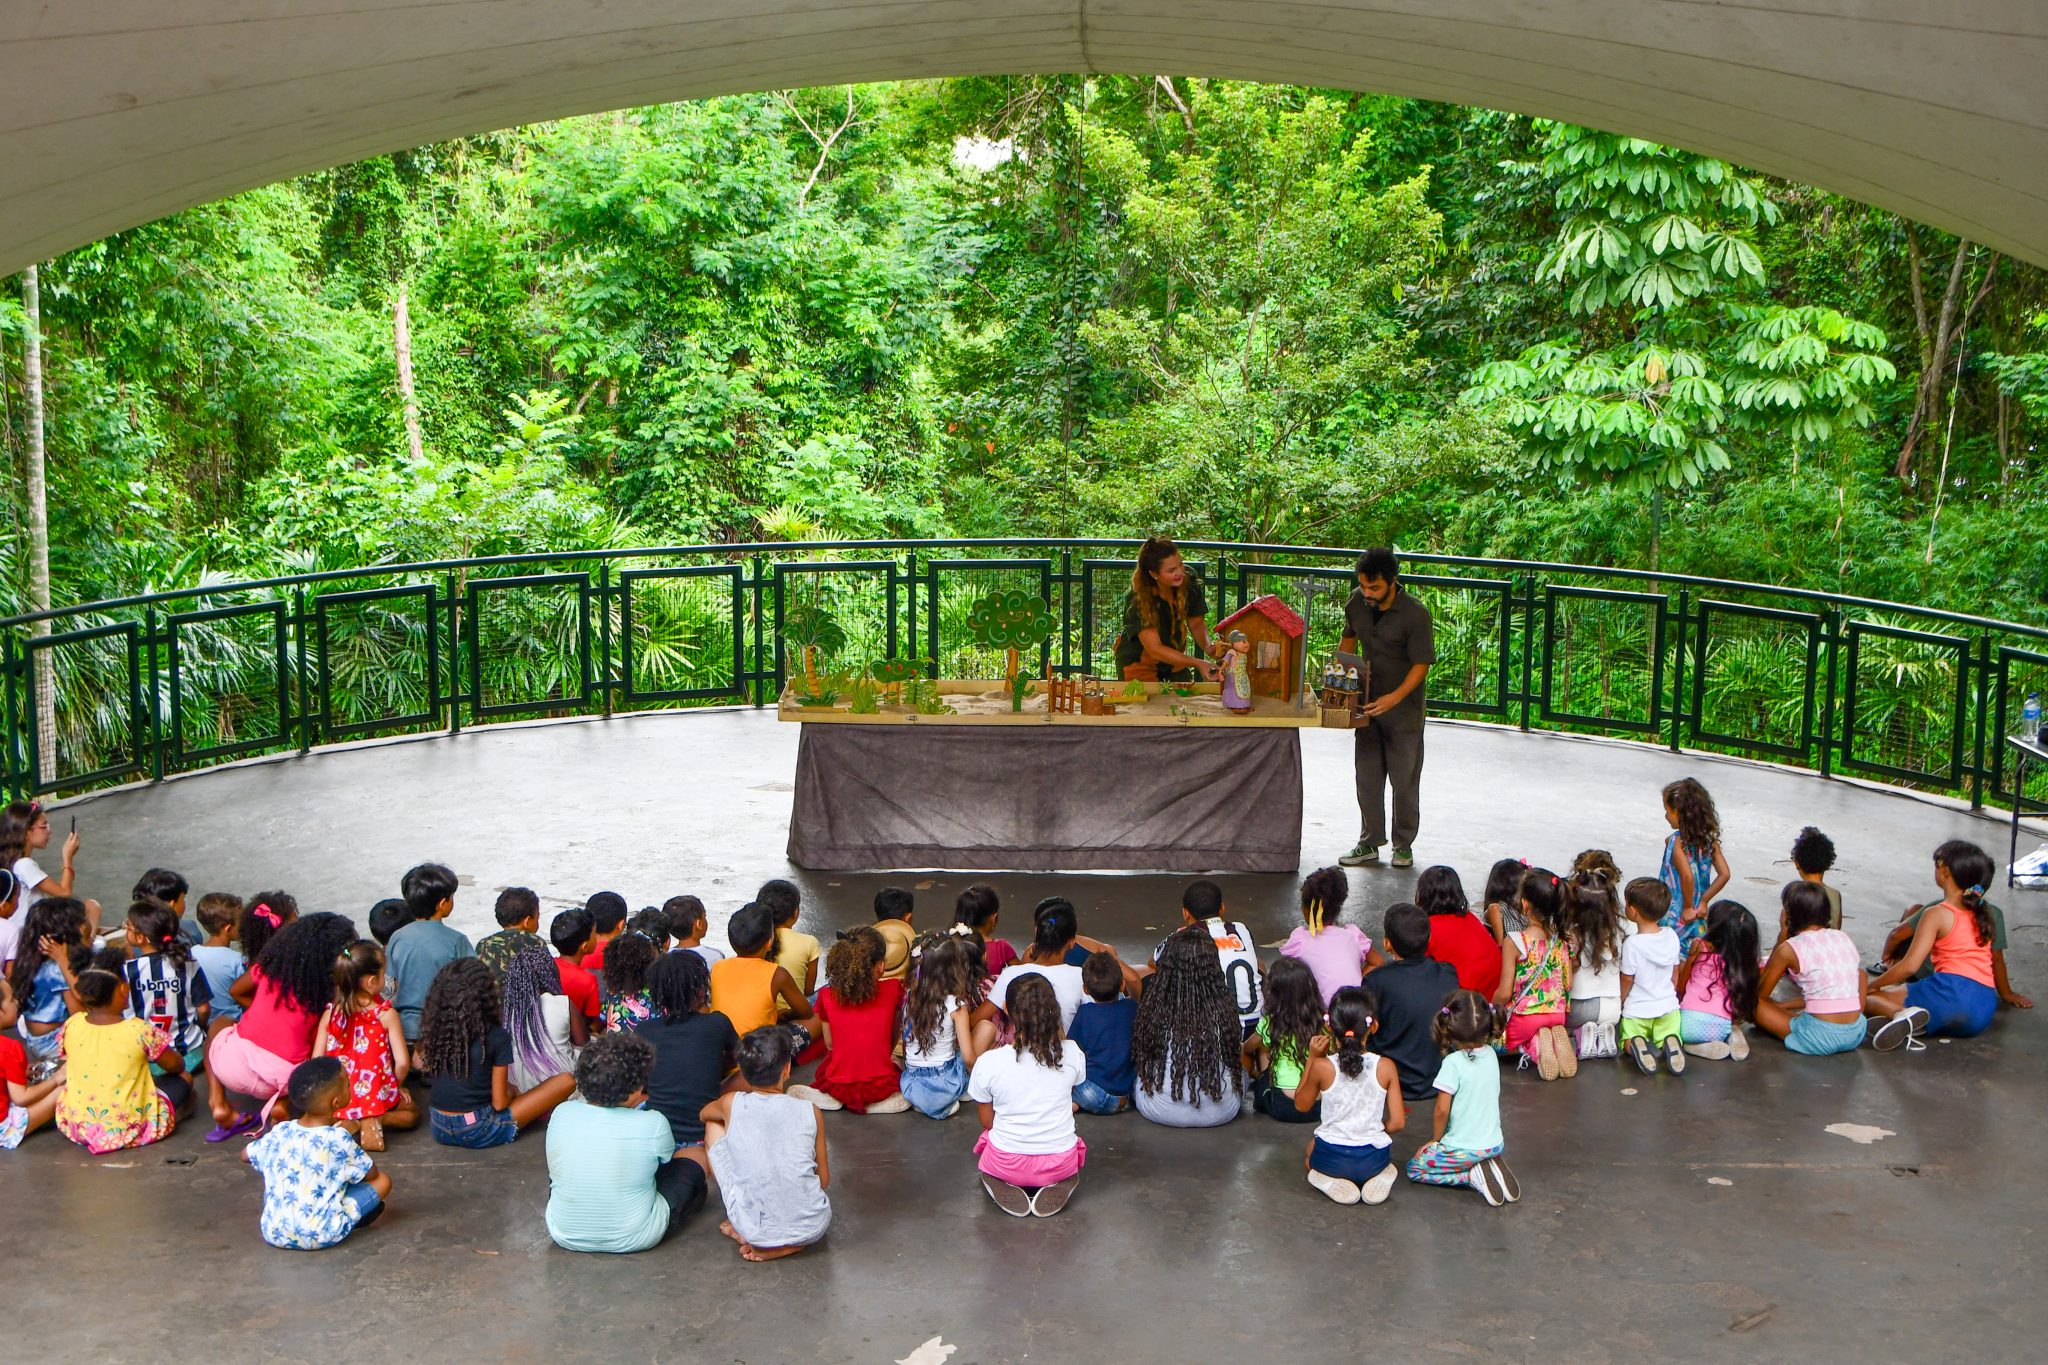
[1337,548,1436,868]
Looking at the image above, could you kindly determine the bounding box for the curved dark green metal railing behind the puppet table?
[0,538,2048,806]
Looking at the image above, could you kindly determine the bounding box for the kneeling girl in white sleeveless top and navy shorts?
[1294,986,1407,1203]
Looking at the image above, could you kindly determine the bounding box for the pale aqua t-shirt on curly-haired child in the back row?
[547,1099,676,1250]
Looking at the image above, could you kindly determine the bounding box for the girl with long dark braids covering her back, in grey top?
[1130,925,1243,1128]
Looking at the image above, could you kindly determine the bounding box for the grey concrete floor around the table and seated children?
[0,712,2048,1365]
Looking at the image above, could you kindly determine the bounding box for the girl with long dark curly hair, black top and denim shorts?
[418,958,575,1148]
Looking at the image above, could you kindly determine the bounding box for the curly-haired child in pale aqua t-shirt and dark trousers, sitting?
[547,1033,705,1252]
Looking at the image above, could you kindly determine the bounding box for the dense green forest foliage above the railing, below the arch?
[0,78,2048,620]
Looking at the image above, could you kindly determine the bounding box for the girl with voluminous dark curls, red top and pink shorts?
[207,913,356,1142]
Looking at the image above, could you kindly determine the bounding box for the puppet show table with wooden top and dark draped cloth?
[780,681,1317,872]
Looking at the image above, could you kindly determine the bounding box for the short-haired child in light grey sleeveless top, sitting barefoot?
[702,1023,831,1261]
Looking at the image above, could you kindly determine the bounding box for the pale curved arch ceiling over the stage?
[0,0,2048,274]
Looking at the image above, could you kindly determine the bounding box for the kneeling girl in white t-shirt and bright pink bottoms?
[967,970,1089,1218]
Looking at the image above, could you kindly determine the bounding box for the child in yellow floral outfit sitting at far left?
[57,950,193,1154]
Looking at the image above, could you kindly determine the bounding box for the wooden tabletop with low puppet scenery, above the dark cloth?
[776,677,1323,731]
